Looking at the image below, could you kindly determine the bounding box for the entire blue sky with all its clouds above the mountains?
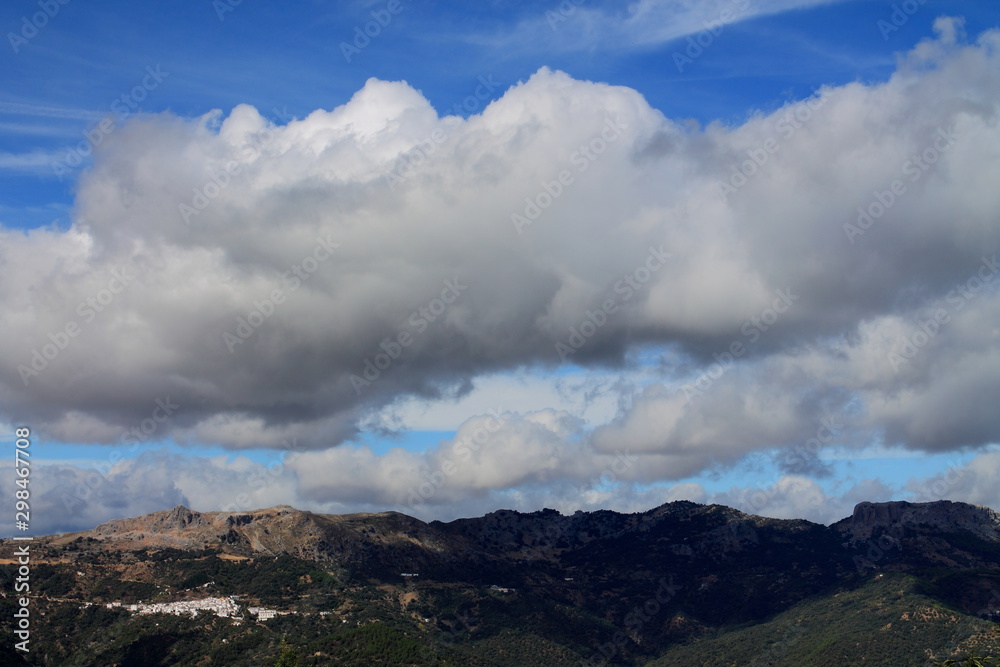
[0,0,1000,534]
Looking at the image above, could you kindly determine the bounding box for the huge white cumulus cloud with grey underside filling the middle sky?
[0,19,1000,502]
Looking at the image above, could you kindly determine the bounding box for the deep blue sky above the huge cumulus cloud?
[0,0,997,215]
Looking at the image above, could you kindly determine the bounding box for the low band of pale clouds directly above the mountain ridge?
[13,446,1000,534]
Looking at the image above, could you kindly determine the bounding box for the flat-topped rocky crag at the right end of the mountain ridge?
[835,500,1000,542]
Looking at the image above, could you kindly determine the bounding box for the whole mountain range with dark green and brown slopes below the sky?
[0,501,1000,665]
